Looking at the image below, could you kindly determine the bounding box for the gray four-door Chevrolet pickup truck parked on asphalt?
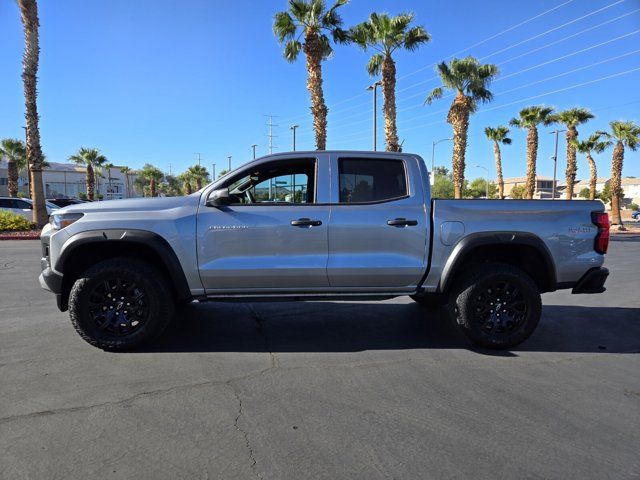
[40,151,609,350]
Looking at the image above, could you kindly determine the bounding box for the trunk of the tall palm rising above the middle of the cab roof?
[304,31,329,150]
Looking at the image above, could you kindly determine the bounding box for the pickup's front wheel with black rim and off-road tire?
[69,258,174,351]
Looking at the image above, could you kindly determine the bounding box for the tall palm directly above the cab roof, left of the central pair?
[273,0,348,150]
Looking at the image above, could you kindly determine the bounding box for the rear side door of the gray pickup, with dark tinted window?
[327,154,429,291]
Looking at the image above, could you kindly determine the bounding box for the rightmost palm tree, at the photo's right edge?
[599,120,640,230]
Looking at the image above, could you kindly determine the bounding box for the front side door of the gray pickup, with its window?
[197,158,329,294]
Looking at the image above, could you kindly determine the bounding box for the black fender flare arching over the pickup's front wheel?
[53,229,192,300]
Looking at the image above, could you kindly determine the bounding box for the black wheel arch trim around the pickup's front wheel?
[54,229,191,311]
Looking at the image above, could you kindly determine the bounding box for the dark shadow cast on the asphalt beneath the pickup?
[144,302,640,356]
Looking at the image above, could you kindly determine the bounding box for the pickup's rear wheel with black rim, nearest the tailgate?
[451,264,542,349]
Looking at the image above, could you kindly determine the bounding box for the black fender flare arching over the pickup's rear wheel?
[437,231,557,292]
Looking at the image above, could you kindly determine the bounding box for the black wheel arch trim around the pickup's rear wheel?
[437,232,557,293]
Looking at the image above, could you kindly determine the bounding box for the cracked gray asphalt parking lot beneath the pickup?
[0,238,640,479]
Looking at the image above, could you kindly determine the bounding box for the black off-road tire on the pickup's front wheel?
[69,257,174,351]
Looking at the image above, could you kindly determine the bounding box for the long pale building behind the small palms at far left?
[0,160,142,200]
